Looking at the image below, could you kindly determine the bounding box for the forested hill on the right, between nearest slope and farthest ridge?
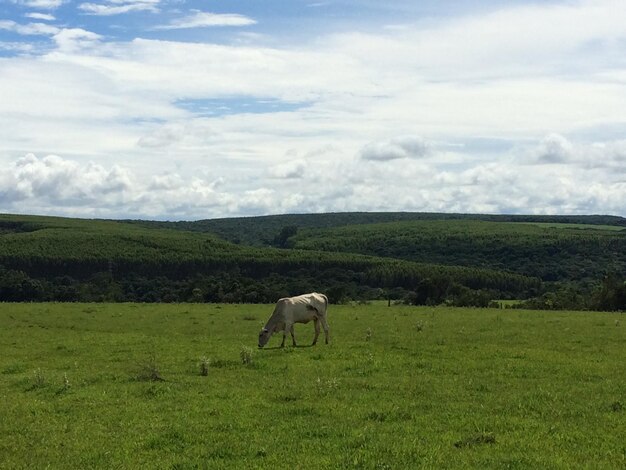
[289,219,626,282]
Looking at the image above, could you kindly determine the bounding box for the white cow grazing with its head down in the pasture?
[259,293,328,348]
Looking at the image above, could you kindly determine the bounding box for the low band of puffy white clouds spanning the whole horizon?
[0,143,626,219]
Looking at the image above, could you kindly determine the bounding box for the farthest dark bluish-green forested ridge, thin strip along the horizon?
[126,212,626,246]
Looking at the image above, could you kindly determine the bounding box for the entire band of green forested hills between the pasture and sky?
[0,213,626,309]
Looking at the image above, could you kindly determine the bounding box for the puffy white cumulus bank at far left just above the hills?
[0,154,228,216]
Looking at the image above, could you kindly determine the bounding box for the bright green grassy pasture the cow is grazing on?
[0,304,626,469]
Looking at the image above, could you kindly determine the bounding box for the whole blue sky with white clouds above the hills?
[0,0,626,220]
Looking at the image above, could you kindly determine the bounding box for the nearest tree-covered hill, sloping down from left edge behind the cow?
[0,215,540,304]
